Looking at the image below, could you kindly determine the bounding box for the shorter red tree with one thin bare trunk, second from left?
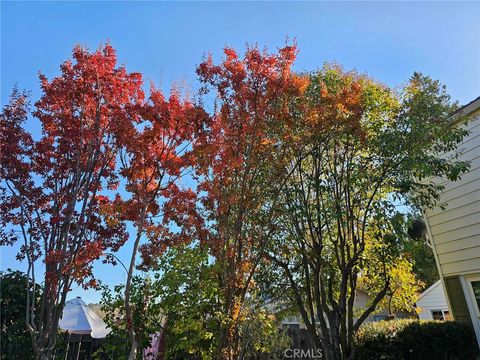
[119,86,207,359]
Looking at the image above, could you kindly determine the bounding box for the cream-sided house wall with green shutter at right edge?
[424,97,480,346]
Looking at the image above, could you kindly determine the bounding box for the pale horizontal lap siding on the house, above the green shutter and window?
[426,116,480,276]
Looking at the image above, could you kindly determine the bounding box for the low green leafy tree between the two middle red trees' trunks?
[155,243,220,359]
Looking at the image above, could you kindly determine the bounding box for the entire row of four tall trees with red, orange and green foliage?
[0,44,464,359]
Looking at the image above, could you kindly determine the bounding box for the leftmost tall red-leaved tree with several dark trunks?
[0,45,143,359]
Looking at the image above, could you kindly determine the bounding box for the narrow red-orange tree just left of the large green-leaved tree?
[196,46,306,359]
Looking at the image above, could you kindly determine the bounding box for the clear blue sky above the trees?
[1,1,480,302]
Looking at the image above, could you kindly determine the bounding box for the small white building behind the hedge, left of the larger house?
[416,280,451,320]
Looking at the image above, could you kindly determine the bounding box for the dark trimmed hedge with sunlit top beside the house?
[356,320,478,360]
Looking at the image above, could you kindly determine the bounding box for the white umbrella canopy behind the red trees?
[59,297,111,339]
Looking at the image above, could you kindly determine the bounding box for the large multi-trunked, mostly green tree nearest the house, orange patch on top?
[268,66,467,360]
